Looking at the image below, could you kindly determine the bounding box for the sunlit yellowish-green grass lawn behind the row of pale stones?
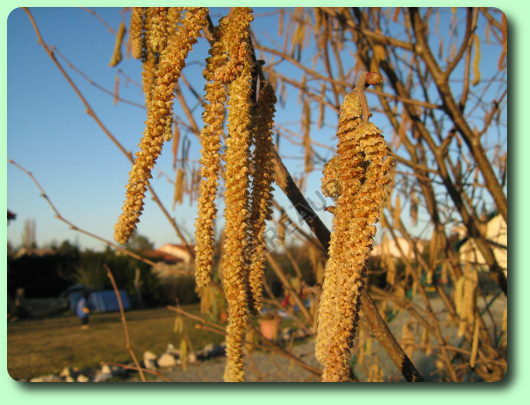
[7,305,224,379]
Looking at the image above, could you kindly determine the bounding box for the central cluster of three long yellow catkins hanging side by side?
[195,8,276,382]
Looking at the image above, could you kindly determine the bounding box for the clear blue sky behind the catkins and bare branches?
[7,8,504,249]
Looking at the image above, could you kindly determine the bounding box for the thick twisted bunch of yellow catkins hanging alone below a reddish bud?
[315,73,393,382]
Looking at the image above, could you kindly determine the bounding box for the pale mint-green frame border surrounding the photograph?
[0,0,520,405]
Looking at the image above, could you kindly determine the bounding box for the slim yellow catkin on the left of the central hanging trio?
[191,17,229,288]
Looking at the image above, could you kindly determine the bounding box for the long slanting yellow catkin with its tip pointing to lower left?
[114,7,208,243]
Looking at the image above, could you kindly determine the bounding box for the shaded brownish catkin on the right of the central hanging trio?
[245,83,276,313]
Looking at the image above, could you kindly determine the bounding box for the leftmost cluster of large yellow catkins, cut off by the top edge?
[114,7,208,243]
